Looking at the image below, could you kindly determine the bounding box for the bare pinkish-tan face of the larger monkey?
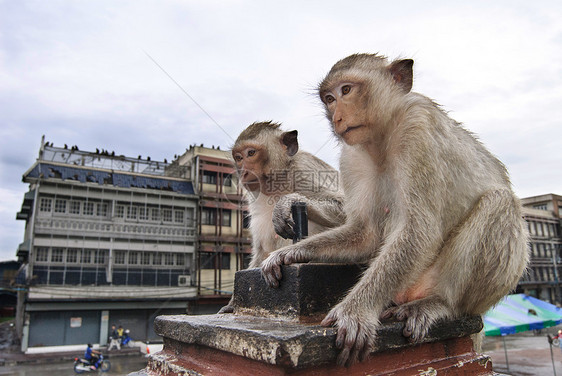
[320,80,370,145]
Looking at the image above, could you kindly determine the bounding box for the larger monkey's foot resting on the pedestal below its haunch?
[380,297,451,342]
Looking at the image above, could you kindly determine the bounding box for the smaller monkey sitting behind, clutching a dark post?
[219,121,345,313]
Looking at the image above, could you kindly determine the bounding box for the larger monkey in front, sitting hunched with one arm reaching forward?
[262,54,529,366]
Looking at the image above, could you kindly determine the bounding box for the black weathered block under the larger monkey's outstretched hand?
[230,263,363,322]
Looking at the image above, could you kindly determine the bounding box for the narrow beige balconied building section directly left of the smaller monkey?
[177,145,251,313]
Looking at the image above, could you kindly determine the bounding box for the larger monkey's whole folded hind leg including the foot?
[381,189,528,341]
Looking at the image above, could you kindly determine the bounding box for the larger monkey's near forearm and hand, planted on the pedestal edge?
[322,209,437,365]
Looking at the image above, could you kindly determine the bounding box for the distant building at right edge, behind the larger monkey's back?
[519,194,562,305]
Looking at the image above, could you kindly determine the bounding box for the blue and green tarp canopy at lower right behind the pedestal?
[484,294,562,336]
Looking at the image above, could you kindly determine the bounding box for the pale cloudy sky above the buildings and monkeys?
[0,0,562,261]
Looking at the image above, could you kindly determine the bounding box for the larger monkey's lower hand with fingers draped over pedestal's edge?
[321,300,379,366]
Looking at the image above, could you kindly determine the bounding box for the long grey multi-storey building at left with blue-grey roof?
[17,141,198,350]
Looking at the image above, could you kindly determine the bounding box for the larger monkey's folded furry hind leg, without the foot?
[434,189,529,315]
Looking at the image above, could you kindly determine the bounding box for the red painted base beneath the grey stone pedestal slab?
[145,337,493,376]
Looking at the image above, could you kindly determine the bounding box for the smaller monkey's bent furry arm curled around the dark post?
[273,192,346,239]
